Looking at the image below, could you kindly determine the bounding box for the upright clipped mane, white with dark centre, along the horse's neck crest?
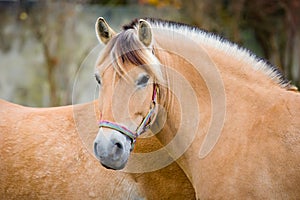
[123,18,293,89]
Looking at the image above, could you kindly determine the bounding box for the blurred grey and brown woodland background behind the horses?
[0,0,300,107]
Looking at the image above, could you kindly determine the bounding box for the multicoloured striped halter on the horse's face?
[99,84,159,151]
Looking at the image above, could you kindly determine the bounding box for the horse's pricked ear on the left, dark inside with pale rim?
[95,17,116,44]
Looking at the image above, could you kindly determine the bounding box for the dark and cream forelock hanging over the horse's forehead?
[98,28,163,82]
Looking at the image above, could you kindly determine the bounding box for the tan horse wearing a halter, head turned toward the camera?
[94,17,300,199]
